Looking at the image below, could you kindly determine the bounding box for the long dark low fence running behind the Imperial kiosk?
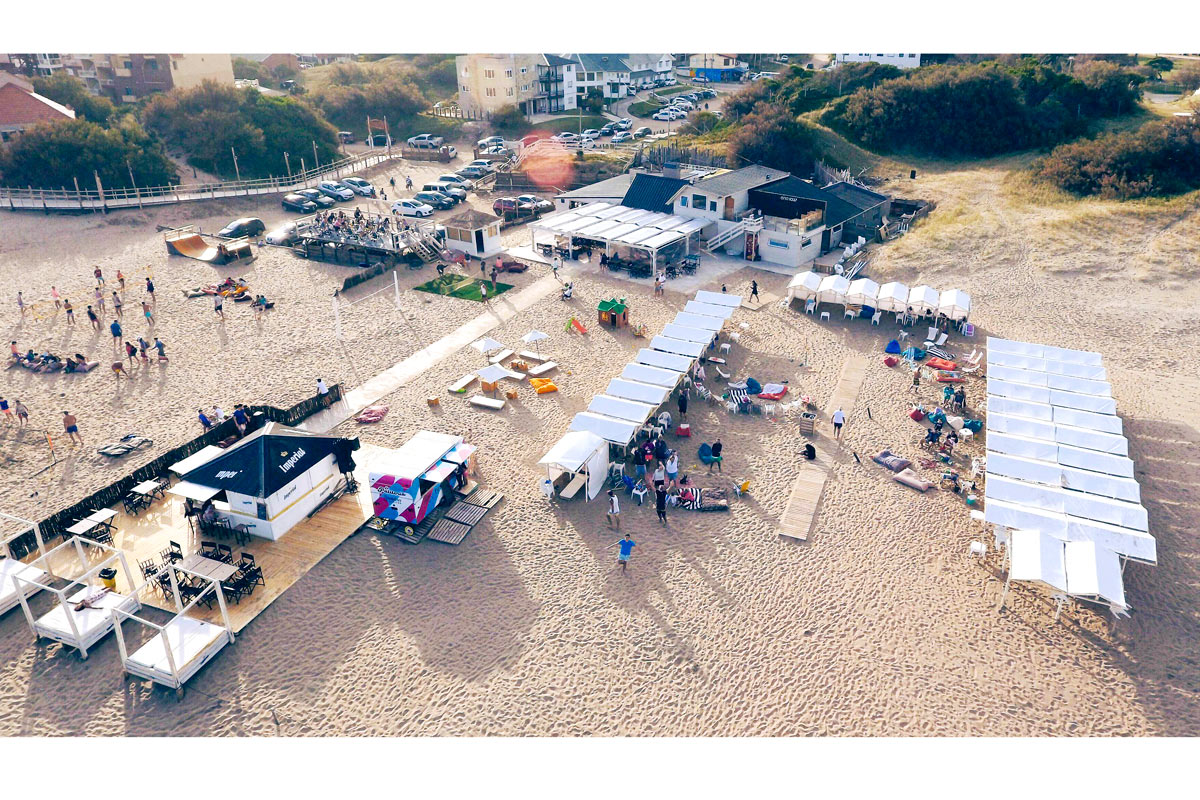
[10,384,342,559]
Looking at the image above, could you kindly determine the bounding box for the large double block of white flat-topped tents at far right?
[984,337,1158,613]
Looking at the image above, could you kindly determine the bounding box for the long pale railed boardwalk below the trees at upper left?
[0,154,400,212]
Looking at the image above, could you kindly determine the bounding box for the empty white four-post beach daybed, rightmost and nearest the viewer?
[113,564,234,698]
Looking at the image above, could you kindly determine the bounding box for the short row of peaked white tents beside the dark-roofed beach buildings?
[787,272,971,321]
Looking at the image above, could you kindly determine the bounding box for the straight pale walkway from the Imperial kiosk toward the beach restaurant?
[296,275,562,433]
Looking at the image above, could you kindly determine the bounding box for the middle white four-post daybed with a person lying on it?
[12,536,142,658]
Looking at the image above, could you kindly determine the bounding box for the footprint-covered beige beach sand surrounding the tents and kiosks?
[0,151,1200,735]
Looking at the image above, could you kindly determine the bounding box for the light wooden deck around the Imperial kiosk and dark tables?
[50,444,388,632]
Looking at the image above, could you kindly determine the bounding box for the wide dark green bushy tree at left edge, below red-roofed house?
[0,115,179,188]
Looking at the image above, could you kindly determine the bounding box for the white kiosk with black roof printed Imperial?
[175,422,342,540]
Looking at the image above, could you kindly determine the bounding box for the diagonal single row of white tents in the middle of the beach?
[538,290,742,500]
